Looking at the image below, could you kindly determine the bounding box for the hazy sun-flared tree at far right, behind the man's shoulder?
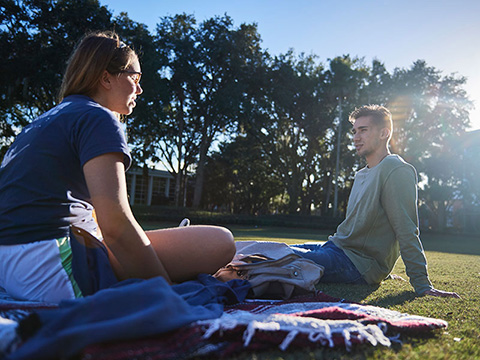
[387,60,472,229]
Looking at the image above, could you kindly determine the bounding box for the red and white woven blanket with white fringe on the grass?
[80,292,447,360]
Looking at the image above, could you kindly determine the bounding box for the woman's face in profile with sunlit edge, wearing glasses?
[105,60,143,115]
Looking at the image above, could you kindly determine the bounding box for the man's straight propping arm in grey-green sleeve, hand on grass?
[382,166,459,297]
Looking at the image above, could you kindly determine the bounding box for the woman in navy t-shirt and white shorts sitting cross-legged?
[0,32,235,302]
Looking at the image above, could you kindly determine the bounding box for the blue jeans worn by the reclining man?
[290,241,367,285]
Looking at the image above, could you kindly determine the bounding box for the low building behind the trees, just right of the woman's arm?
[127,168,175,206]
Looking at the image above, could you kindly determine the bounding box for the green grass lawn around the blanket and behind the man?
[144,224,480,360]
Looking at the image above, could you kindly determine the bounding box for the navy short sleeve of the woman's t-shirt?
[71,108,131,169]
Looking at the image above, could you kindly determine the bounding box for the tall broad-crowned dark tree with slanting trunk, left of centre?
[152,14,262,207]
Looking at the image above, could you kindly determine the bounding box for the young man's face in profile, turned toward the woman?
[352,116,385,157]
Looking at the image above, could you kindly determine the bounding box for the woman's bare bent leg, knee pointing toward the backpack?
[146,225,235,282]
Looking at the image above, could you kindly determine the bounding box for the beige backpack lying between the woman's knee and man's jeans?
[214,241,324,300]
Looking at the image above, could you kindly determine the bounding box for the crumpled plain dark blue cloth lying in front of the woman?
[9,275,250,360]
